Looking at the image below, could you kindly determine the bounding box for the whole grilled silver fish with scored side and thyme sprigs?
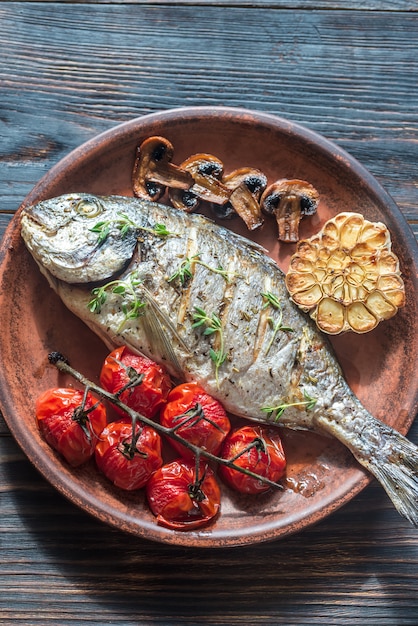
[21,193,418,526]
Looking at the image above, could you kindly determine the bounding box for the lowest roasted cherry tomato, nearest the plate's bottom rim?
[146,459,221,530]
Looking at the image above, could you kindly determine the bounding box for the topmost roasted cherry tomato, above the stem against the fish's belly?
[100,346,172,418]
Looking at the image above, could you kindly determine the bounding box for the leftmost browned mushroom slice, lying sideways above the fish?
[132,136,193,201]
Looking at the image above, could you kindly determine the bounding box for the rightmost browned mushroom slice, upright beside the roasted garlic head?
[260,178,319,242]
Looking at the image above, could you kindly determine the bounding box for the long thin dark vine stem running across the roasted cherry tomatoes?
[48,352,283,489]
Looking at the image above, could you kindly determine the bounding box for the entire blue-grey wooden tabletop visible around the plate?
[0,0,418,626]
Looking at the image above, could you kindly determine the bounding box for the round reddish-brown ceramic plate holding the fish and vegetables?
[0,107,418,547]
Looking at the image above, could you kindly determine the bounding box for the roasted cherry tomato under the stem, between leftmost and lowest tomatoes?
[95,421,163,491]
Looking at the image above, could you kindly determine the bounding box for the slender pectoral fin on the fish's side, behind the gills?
[141,285,190,374]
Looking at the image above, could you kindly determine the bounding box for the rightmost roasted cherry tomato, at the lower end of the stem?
[219,426,286,494]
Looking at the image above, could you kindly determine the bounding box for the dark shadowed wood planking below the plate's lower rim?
[0,433,418,626]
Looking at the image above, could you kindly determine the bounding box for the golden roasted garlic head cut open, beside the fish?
[286,212,405,335]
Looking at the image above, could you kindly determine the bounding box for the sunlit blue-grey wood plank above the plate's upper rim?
[0,2,418,233]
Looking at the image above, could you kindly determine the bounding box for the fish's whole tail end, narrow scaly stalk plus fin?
[319,409,418,527]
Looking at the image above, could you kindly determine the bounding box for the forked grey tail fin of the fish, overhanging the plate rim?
[358,427,418,527]
